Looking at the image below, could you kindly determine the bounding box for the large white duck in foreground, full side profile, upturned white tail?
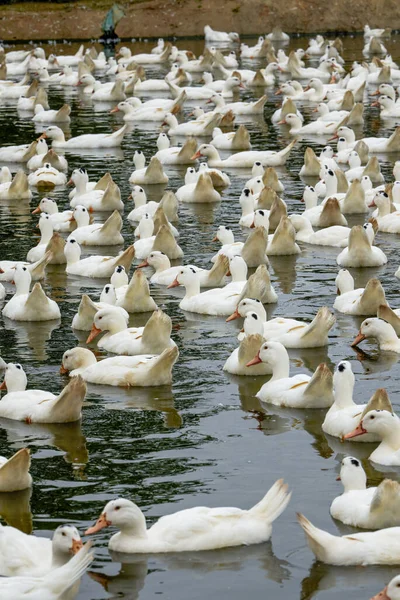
[86,479,290,554]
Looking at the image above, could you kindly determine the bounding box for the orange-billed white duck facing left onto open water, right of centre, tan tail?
[247,341,333,408]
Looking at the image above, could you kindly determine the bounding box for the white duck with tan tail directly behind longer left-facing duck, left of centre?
[86,308,176,356]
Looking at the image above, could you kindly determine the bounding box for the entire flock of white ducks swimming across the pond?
[0,19,400,600]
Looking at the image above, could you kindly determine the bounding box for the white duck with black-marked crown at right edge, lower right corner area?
[330,456,400,529]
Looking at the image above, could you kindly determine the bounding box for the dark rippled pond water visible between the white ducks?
[0,31,400,600]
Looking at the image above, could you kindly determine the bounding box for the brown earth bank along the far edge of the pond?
[0,0,400,43]
